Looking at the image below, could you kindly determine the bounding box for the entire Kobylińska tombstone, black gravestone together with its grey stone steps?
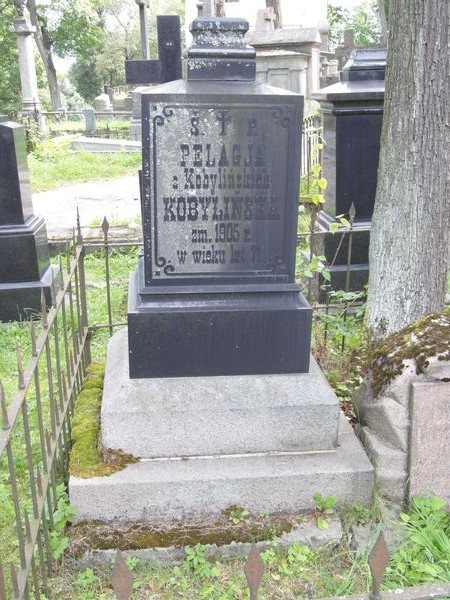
[70,17,372,522]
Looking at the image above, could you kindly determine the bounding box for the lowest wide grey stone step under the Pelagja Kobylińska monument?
[69,417,373,522]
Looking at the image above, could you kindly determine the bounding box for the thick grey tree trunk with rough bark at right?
[368,0,450,336]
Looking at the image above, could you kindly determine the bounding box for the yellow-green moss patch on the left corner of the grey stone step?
[70,363,138,478]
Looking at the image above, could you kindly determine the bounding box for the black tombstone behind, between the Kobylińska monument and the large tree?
[313,49,386,290]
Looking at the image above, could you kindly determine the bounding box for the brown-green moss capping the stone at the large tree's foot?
[370,311,450,398]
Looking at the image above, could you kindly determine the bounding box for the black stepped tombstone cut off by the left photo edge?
[0,119,58,321]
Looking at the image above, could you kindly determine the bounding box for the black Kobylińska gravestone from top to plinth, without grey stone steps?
[128,17,311,378]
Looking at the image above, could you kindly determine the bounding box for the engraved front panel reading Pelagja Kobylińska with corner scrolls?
[143,95,301,285]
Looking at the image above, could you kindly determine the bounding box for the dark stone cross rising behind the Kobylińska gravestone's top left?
[125,15,181,85]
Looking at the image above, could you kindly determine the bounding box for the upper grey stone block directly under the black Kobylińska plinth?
[101,330,340,458]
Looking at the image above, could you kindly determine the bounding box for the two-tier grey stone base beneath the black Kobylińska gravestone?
[69,331,373,522]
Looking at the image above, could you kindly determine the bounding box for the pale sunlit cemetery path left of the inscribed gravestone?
[33,174,141,240]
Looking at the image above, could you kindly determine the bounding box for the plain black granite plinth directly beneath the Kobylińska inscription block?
[128,268,311,379]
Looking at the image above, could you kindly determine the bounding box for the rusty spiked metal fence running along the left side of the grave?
[0,237,90,600]
